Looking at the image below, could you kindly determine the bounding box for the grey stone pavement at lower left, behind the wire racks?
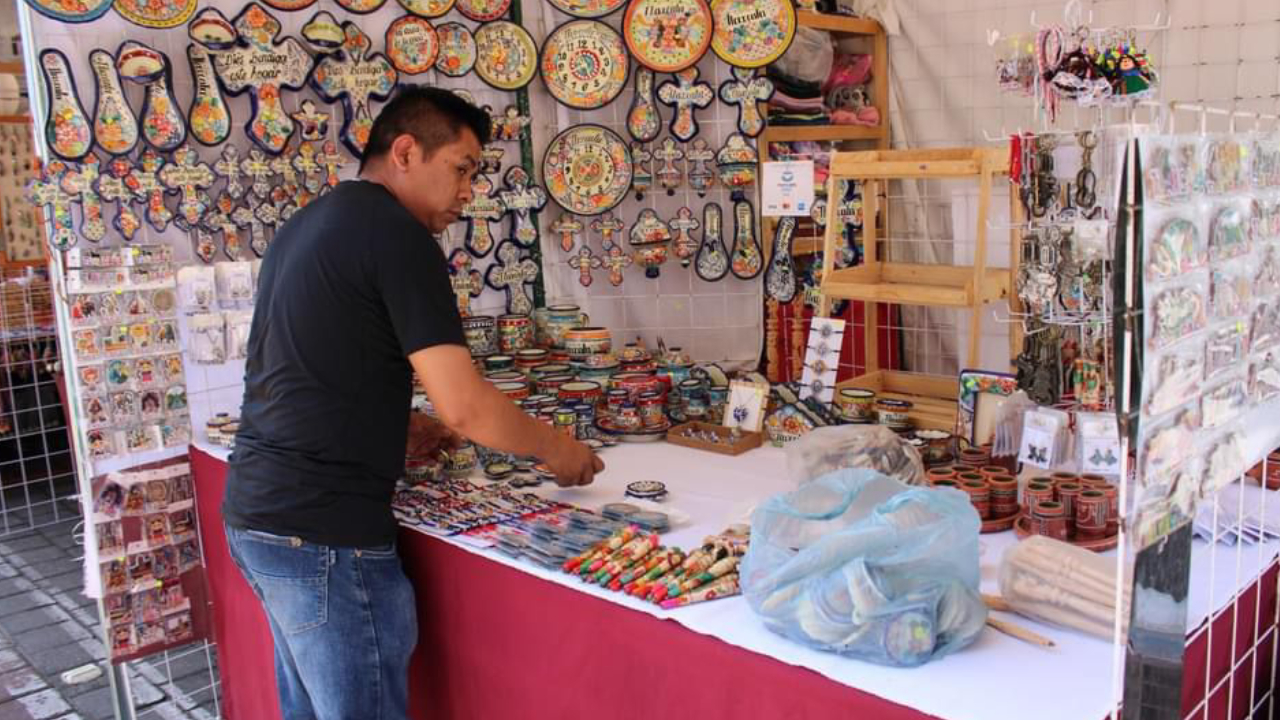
[0,521,218,720]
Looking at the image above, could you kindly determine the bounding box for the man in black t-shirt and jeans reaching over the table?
[223,87,604,720]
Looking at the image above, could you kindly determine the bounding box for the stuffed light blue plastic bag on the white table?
[740,469,987,666]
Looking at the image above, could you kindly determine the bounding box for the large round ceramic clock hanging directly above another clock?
[541,20,628,110]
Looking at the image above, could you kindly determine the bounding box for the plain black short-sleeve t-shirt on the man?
[223,181,466,547]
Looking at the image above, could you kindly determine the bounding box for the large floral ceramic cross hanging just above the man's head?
[311,20,399,158]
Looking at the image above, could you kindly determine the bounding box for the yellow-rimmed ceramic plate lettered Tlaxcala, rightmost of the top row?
[712,0,796,68]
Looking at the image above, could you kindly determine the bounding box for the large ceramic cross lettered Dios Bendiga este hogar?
[214,3,312,155]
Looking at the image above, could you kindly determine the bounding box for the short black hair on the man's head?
[360,85,492,170]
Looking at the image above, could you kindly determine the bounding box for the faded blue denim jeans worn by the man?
[227,527,417,720]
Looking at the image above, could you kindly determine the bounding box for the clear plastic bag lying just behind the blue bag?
[786,425,927,486]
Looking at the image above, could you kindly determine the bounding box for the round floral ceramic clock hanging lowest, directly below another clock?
[543,124,632,215]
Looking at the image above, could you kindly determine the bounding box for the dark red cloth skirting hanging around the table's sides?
[191,448,1277,720]
